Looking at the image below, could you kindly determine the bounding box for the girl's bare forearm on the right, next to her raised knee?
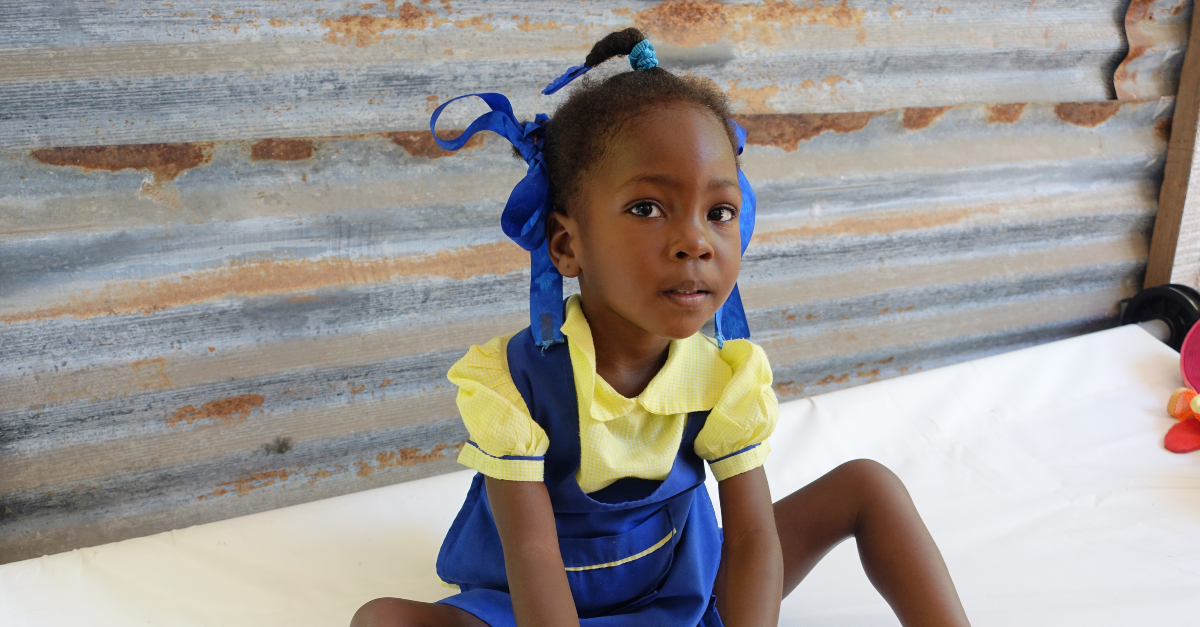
[716,466,784,627]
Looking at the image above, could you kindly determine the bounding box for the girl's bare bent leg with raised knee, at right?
[775,460,968,626]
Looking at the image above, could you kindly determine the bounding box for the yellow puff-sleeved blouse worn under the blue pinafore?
[448,295,779,492]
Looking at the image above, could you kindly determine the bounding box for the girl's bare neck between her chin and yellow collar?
[581,300,671,399]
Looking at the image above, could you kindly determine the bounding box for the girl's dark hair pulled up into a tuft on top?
[542,28,737,214]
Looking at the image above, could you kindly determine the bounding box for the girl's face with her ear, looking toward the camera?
[551,102,742,339]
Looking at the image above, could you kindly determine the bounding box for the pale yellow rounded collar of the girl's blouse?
[562,294,733,420]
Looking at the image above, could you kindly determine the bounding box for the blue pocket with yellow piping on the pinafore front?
[558,507,680,619]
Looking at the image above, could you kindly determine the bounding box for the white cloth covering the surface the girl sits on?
[0,327,1200,627]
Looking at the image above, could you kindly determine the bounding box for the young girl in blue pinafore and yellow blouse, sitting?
[352,29,967,627]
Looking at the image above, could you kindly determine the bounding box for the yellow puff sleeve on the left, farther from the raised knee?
[446,335,550,482]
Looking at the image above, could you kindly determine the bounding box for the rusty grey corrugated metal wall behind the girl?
[0,0,1190,561]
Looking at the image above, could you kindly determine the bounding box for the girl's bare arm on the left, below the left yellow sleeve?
[485,476,583,627]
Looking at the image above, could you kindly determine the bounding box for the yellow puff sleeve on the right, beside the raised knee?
[695,340,779,482]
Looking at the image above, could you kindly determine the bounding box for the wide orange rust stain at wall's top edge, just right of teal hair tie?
[634,0,866,48]
